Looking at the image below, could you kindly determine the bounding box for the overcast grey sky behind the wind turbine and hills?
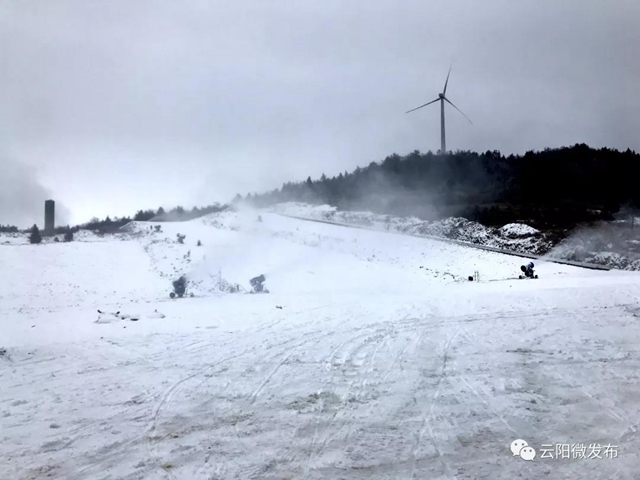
[0,0,640,225]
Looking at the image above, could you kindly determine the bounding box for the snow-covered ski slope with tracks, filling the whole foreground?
[0,212,640,480]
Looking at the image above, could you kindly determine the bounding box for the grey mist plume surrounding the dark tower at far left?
[0,158,70,228]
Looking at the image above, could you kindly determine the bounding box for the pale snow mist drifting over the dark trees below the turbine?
[249,151,503,220]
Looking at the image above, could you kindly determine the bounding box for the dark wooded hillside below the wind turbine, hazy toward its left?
[242,144,640,228]
